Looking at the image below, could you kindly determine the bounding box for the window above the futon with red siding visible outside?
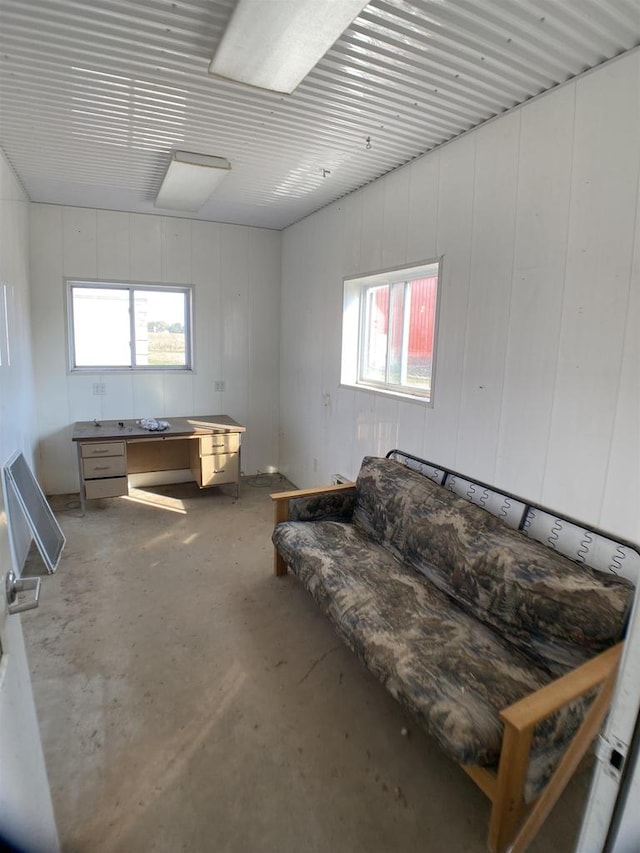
[341,261,440,401]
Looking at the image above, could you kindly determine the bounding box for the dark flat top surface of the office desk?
[71,415,247,441]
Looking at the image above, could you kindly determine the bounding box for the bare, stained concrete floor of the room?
[23,482,589,853]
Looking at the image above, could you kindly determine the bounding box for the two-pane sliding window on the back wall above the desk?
[67,281,192,370]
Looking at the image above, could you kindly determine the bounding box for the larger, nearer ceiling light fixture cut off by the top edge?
[209,0,369,95]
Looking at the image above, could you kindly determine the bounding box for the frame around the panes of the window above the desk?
[64,278,195,373]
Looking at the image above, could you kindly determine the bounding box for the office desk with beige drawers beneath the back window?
[72,415,246,512]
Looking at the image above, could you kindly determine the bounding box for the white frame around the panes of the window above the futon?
[340,256,443,407]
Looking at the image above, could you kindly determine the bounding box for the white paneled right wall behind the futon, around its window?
[280,51,640,540]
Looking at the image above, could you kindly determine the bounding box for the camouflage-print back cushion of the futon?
[353,457,633,674]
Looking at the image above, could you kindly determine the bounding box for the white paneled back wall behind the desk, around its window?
[30,204,281,494]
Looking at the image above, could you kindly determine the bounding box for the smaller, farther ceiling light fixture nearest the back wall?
[155,151,231,211]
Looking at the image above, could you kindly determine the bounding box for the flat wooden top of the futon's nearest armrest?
[500,643,624,731]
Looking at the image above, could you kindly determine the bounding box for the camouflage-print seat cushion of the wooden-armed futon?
[273,522,563,765]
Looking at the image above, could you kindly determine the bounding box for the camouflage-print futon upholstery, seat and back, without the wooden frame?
[273,457,633,849]
